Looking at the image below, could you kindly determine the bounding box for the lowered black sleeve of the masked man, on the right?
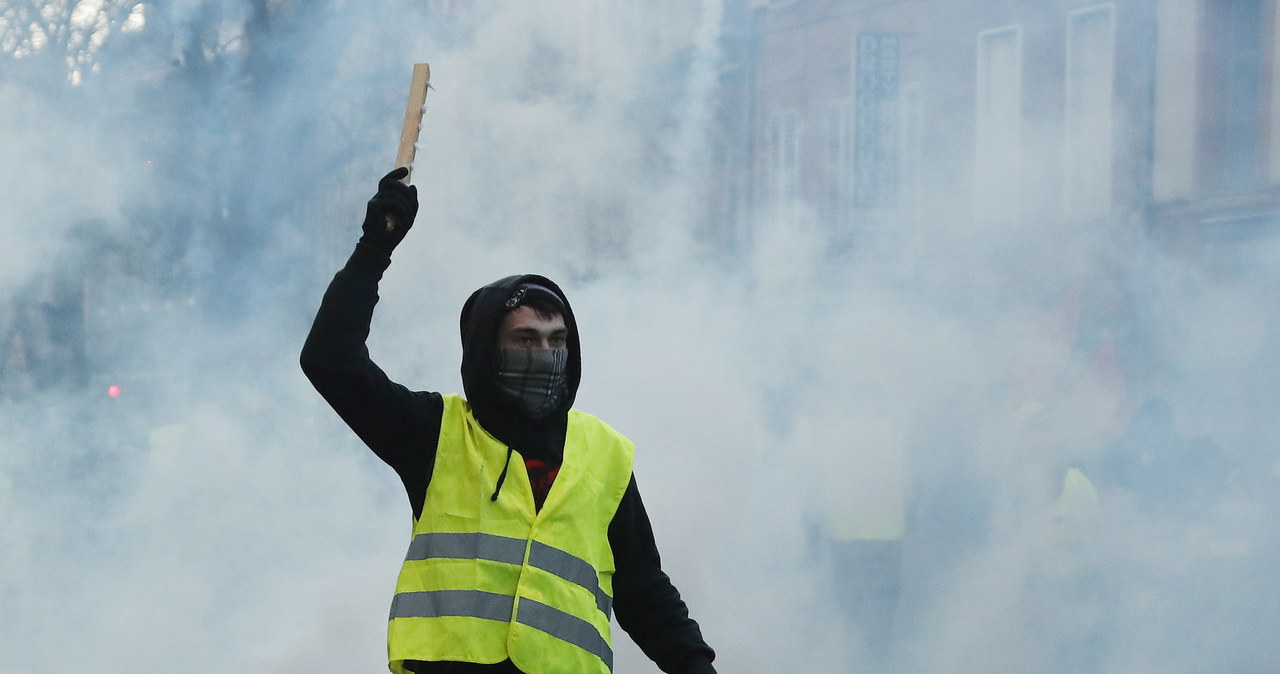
[609,476,716,674]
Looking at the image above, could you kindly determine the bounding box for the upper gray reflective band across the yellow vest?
[404,533,613,616]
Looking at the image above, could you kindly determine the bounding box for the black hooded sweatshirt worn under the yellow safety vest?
[301,243,714,674]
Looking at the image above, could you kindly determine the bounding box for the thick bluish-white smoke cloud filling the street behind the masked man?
[0,0,1280,674]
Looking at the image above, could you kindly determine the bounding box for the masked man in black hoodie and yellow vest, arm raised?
[302,169,716,674]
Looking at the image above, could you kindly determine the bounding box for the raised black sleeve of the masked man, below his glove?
[301,243,444,509]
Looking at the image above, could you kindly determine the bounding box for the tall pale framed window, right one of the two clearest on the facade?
[1062,5,1115,217]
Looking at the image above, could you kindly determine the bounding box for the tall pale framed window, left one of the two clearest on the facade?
[974,26,1023,224]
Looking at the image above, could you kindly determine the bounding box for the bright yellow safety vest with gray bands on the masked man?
[387,395,635,674]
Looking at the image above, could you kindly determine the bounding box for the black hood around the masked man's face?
[460,274,582,450]
